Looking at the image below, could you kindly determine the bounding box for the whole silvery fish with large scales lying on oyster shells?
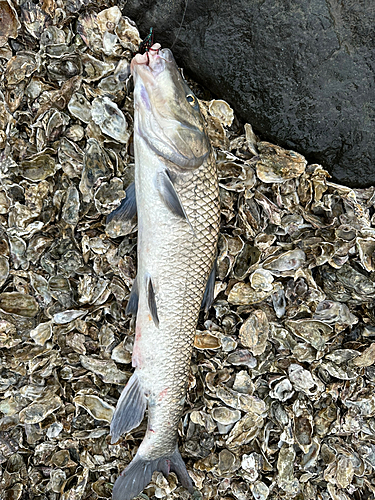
[110,43,220,500]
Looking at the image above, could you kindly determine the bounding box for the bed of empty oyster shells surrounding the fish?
[0,0,375,500]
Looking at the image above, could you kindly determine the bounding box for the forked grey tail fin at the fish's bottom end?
[112,447,194,500]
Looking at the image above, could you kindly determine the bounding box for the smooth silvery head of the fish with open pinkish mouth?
[131,44,210,170]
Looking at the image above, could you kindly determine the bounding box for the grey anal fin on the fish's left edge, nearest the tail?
[111,372,147,444]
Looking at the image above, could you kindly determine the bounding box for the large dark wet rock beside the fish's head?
[124,0,375,186]
